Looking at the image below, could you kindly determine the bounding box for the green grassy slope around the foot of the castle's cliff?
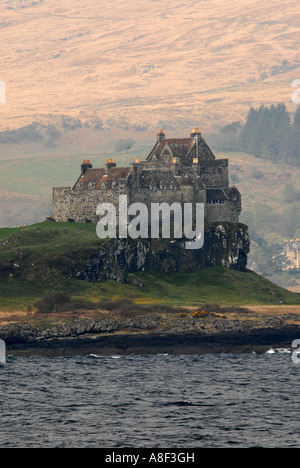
[0,223,300,310]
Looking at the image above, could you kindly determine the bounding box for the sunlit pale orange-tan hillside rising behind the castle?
[0,0,300,132]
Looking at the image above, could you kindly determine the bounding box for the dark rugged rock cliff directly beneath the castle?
[74,223,250,281]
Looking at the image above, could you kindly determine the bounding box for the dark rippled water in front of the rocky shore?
[0,353,300,448]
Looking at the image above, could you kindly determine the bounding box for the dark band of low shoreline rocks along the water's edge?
[0,314,300,357]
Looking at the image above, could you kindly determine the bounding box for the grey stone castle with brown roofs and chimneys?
[52,128,241,223]
